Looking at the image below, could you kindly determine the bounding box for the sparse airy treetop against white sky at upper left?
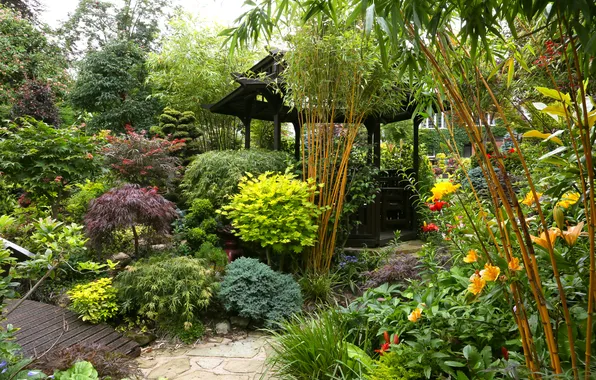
[59,0,171,54]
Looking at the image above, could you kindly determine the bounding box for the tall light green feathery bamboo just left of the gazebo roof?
[148,15,256,151]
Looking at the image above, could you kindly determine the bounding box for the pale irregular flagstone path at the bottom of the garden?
[137,332,273,380]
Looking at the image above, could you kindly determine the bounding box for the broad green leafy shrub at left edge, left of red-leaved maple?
[0,119,103,216]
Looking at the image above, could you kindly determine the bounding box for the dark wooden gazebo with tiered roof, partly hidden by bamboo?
[204,51,421,247]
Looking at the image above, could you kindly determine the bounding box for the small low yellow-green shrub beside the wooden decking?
[68,278,118,323]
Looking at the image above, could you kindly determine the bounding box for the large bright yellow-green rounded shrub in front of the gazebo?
[221,173,319,253]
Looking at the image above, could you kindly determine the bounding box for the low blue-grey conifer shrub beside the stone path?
[219,257,302,327]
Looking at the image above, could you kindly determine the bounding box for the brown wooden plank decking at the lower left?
[2,300,141,357]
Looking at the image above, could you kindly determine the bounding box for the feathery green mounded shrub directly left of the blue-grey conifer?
[114,257,218,330]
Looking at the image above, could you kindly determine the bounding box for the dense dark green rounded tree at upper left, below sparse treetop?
[70,41,160,132]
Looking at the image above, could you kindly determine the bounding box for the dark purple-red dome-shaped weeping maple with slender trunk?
[85,184,178,255]
